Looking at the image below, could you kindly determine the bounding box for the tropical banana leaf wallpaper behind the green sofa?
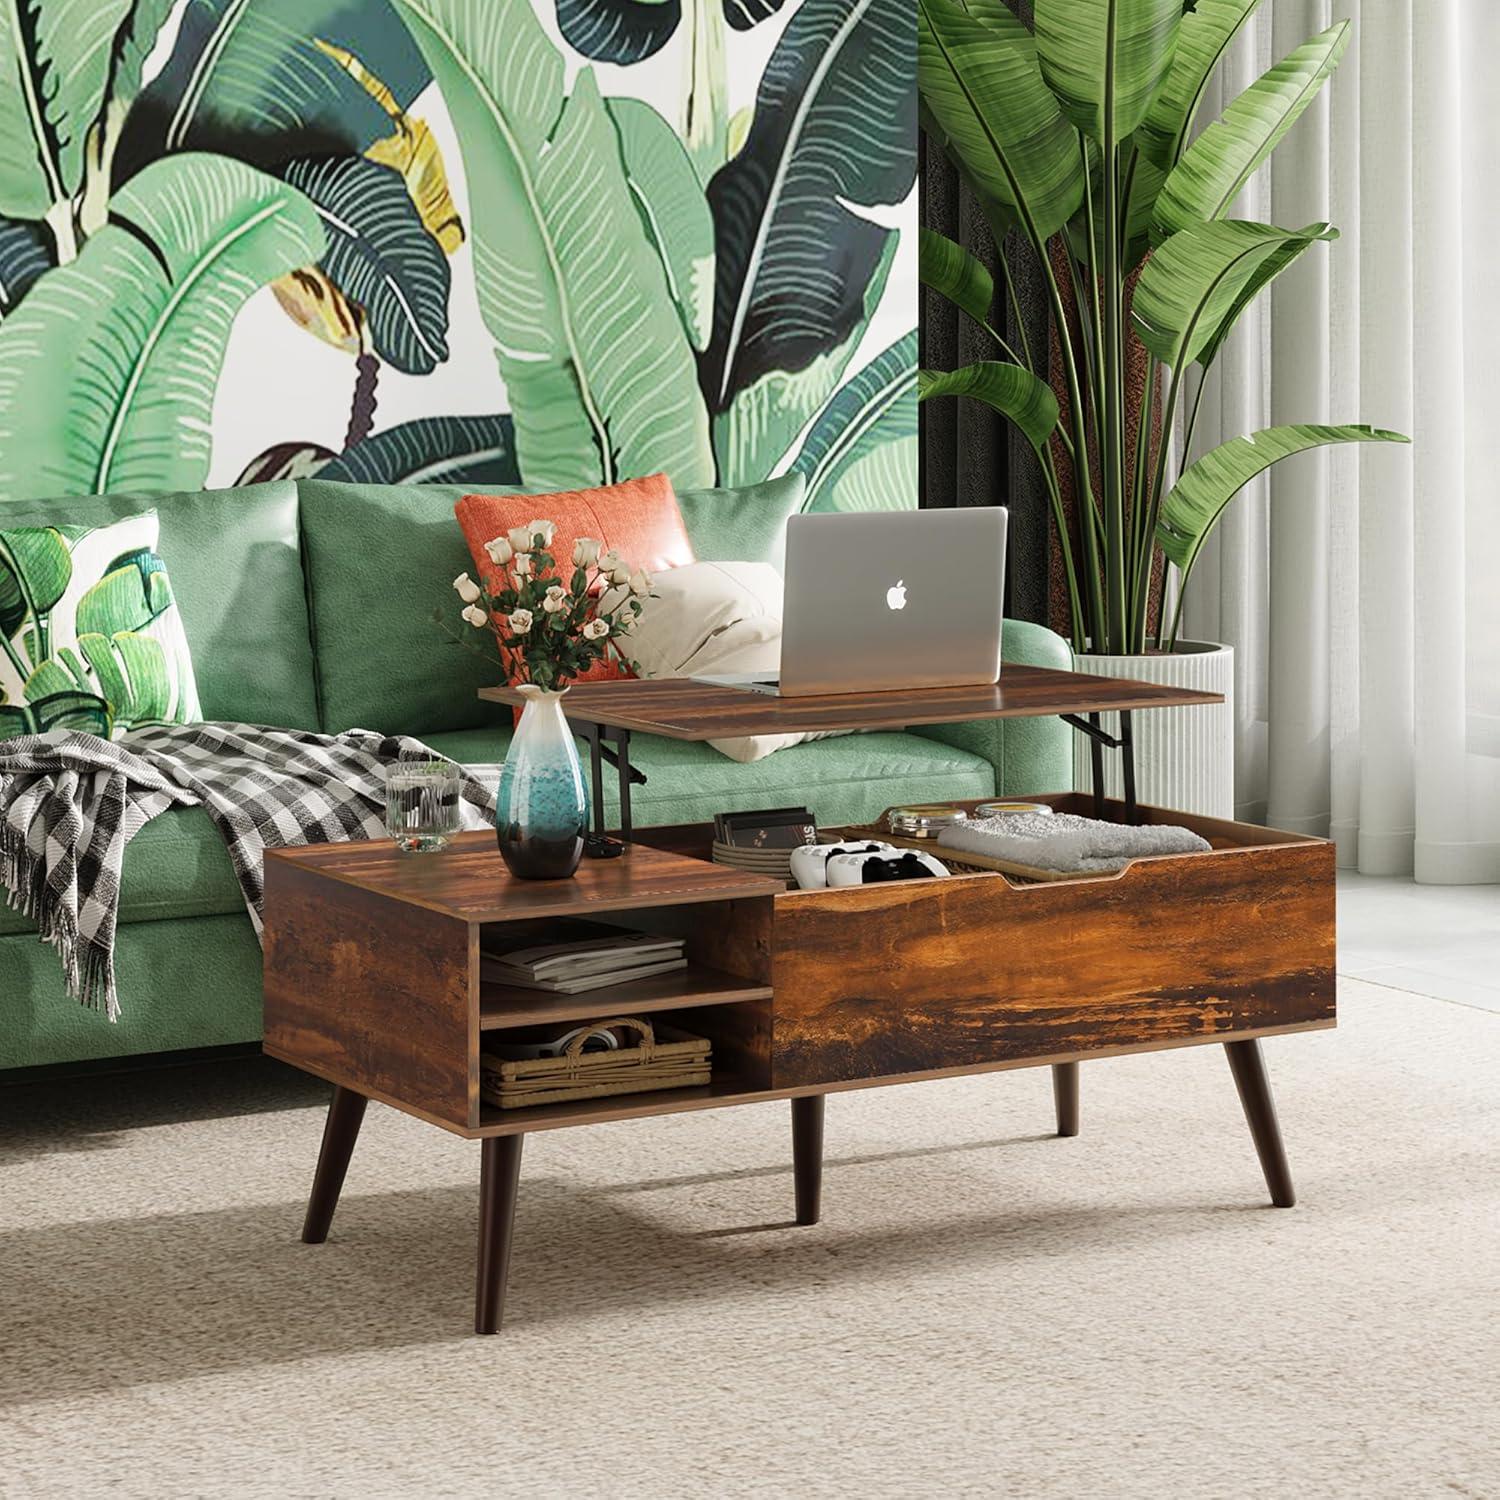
[0,0,917,510]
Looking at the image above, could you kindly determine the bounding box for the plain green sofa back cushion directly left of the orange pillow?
[297,479,530,735]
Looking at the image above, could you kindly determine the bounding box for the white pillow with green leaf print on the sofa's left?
[0,510,203,740]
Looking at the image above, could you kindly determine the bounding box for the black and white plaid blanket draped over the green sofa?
[0,725,495,1020]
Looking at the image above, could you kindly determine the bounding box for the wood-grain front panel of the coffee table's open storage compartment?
[771,842,1334,1089]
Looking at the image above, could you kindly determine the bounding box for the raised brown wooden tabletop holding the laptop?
[479,663,1224,740]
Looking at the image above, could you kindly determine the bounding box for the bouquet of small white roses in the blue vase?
[437,521,651,692]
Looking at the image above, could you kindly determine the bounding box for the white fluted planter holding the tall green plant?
[1073,641,1235,818]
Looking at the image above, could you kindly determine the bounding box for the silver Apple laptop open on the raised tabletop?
[702,506,1010,698]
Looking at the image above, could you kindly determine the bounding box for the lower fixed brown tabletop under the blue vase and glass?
[266,830,786,923]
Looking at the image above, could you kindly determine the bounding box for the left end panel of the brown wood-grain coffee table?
[264,854,479,1127]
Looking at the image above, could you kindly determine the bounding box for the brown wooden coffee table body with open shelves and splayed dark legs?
[264,674,1335,1332]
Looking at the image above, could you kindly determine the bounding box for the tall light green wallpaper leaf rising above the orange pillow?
[399,0,714,489]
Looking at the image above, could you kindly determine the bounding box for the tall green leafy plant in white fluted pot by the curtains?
[918,0,1407,816]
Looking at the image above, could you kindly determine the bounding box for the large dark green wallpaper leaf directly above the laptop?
[699,0,917,485]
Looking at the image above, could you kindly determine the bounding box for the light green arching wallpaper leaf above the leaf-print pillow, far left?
[0,155,323,500]
